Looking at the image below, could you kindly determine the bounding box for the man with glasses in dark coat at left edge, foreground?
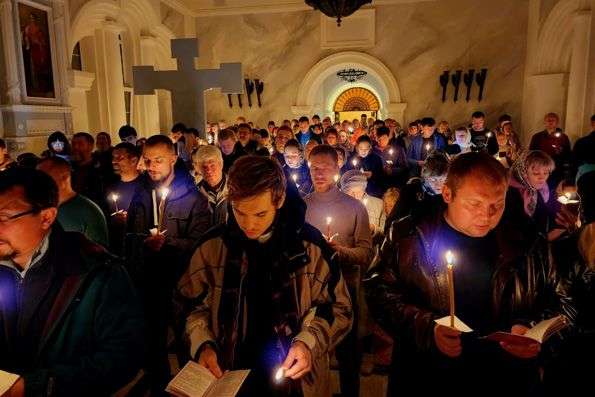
[0,168,143,396]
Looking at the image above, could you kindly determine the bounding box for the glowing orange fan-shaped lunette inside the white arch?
[333,87,380,122]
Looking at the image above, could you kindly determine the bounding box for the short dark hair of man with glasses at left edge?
[0,167,58,213]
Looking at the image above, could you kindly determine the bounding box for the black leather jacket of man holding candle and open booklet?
[365,210,575,380]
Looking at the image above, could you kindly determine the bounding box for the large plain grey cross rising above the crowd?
[132,39,244,136]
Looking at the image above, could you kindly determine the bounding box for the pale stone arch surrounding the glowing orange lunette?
[292,51,407,124]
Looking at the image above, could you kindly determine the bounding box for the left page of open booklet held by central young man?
[165,361,217,397]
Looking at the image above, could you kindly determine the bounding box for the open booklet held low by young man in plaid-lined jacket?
[165,361,250,397]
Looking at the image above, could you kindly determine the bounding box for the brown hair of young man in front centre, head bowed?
[227,156,286,205]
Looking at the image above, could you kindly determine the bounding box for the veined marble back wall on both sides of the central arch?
[196,0,528,133]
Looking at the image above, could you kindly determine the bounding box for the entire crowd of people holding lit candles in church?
[0,112,595,396]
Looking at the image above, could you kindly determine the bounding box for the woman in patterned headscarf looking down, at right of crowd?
[504,150,573,241]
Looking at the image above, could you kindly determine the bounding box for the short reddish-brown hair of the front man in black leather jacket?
[446,152,508,196]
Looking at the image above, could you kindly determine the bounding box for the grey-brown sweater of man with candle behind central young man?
[304,187,373,274]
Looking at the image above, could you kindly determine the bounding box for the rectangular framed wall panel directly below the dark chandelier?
[320,8,376,49]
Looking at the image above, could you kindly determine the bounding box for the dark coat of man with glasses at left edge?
[0,226,144,396]
